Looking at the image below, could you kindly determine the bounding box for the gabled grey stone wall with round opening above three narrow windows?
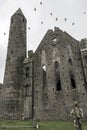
[34,28,87,120]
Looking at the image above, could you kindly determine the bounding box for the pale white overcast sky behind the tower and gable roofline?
[0,0,87,83]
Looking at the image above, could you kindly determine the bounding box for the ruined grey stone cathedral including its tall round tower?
[0,9,87,120]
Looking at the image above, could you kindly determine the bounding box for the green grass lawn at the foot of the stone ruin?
[0,120,87,130]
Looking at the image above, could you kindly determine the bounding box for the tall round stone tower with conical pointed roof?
[3,8,26,119]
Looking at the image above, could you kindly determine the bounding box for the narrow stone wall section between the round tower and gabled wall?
[24,51,33,119]
